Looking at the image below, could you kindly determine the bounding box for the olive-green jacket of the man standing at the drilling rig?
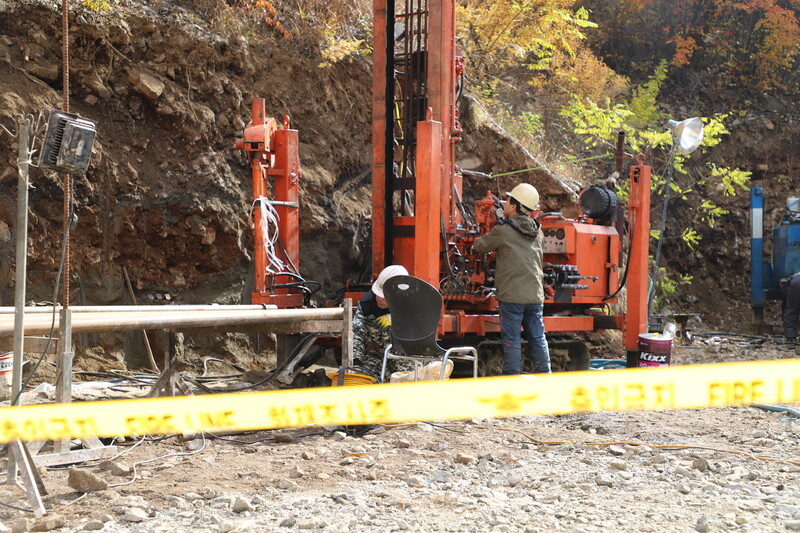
[472,215,544,304]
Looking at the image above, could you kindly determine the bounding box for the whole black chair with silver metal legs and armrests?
[381,276,478,382]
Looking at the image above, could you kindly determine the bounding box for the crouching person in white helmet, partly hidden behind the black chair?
[353,265,414,379]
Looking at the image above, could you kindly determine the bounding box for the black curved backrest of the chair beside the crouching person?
[383,276,444,357]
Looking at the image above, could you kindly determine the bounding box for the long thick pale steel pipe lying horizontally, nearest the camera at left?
[0,307,344,337]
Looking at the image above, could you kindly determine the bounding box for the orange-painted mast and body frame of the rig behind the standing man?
[368,0,650,358]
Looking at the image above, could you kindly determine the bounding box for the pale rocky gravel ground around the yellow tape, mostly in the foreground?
[0,335,800,533]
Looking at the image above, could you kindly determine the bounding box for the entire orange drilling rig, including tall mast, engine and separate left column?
[237,0,650,374]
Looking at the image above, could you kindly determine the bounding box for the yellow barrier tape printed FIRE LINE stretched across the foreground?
[0,359,800,442]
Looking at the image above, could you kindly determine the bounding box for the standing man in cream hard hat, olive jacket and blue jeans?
[473,183,550,375]
